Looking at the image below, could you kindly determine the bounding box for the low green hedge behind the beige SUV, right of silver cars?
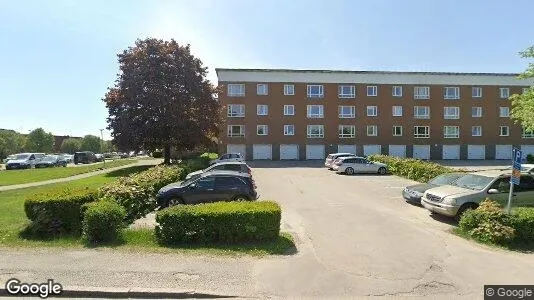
[367,155,458,182]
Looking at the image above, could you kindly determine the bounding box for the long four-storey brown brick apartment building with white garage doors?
[216,69,534,160]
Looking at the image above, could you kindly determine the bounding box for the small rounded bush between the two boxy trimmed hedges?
[83,199,126,244]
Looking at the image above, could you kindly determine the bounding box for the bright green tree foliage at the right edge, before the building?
[510,46,534,131]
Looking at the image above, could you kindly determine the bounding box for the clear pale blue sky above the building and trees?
[0,0,534,139]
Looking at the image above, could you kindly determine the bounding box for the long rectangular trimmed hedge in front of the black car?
[156,201,281,245]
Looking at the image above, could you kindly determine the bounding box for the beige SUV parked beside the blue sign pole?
[421,170,534,220]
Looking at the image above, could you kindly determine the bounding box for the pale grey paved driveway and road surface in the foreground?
[0,162,534,299]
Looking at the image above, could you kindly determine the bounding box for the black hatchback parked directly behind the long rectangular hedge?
[157,171,258,207]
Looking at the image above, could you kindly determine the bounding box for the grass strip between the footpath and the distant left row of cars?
[0,159,137,186]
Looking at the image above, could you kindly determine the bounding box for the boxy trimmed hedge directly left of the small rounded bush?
[24,189,97,235]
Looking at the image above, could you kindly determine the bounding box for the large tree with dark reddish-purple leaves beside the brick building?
[103,38,220,163]
